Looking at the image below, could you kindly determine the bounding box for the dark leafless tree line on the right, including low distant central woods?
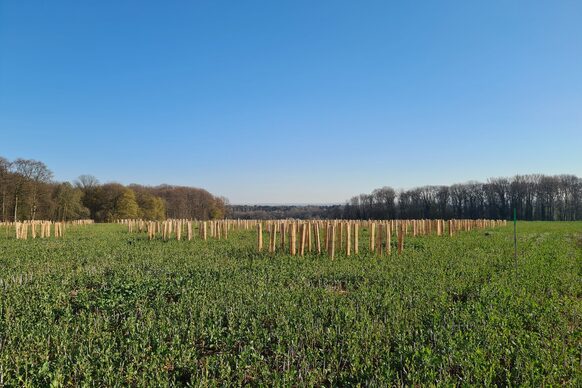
[229,174,582,221]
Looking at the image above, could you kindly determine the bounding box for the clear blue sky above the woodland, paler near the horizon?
[0,0,582,203]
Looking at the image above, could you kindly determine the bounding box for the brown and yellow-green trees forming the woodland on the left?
[0,157,227,222]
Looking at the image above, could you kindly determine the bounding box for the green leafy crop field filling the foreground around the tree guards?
[0,222,582,386]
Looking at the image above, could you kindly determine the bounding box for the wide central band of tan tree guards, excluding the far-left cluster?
[119,220,507,258]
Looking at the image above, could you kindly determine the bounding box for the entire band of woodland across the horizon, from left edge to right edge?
[0,157,582,222]
